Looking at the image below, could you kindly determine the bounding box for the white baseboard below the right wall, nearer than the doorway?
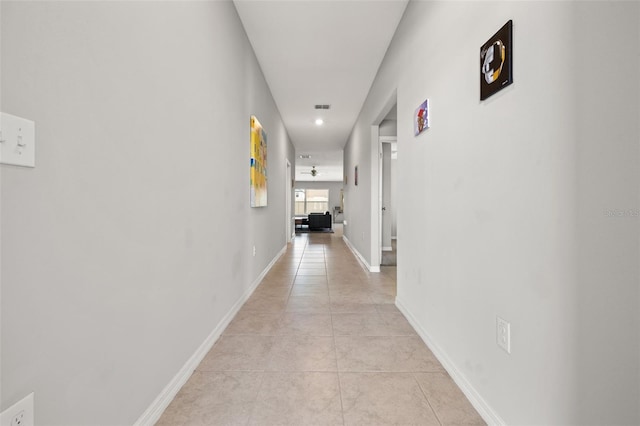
[396,297,506,425]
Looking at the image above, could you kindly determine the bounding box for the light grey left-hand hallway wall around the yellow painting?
[0,1,294,425]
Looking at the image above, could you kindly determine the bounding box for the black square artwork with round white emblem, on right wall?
[480,20,513,101]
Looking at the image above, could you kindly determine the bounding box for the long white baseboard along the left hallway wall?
[134,246,287,426]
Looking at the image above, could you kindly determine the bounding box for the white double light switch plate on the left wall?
[0,112,36,167]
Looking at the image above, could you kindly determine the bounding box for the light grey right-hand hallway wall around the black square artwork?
[345,2,640,424]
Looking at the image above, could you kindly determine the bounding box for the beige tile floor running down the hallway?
[157,233,485,426]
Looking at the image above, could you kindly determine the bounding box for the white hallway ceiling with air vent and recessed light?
[234,0,407,181]
